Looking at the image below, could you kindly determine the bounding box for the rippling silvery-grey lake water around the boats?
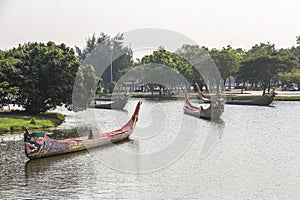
[0,100,300,199]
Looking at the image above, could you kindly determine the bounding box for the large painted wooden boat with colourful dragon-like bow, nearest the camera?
[24,102,141,159]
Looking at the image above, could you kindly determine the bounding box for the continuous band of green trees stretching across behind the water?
[0,33,300,115]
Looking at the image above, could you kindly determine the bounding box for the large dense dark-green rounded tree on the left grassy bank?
[8,42,80,113]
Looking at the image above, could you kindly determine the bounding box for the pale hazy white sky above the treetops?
[0,0,300,49]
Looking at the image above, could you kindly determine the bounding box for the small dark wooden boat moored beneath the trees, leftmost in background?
[89,97,128,110]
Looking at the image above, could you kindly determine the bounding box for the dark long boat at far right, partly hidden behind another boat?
[196,83,276,106]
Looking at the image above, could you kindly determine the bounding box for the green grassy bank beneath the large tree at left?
[0,111,65,133]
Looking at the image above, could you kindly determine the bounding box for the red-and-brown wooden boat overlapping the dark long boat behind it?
[183,89,224,120]
